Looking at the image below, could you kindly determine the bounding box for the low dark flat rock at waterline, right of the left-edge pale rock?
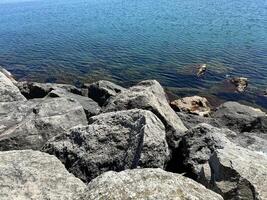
[16,81,81,99]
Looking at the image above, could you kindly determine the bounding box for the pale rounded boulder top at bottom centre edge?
[77,168,223,200]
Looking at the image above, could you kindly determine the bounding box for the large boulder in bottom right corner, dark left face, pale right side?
[181,124,267,200]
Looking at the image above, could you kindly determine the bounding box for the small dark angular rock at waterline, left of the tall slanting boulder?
[82,80,125,106]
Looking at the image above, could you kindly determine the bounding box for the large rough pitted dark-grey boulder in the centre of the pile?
[43,109,169,182]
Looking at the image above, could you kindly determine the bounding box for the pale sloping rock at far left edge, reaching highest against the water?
[0,70,26,102]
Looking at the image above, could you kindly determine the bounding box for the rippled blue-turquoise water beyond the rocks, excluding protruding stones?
[0,0,267,108]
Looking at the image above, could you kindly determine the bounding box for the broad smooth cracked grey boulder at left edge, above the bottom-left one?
[0,98,87,151]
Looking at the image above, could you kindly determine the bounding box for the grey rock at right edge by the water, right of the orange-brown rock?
[213,101,267,134]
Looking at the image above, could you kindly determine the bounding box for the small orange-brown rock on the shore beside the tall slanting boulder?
[170,96,211,116]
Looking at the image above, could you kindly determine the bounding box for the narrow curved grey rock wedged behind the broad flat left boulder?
[48,89,101,119]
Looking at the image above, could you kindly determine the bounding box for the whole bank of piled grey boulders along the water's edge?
[0,68,267,200]
